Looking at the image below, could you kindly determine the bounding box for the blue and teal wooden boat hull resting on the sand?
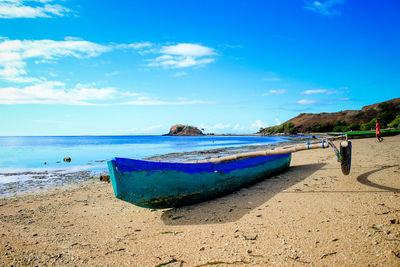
[108,153,291,209]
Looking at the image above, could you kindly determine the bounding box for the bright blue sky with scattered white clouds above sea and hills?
[0,0,400,135]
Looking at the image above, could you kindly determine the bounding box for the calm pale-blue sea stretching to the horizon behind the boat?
[0,136,292,195]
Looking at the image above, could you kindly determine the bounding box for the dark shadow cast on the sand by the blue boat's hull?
[161,163,326,225]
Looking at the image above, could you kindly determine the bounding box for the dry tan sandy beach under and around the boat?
[0,136,400,267]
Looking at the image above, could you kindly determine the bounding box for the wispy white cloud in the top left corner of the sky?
[0,0,71,19]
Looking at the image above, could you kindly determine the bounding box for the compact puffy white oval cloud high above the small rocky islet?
[148,43,216,69]
